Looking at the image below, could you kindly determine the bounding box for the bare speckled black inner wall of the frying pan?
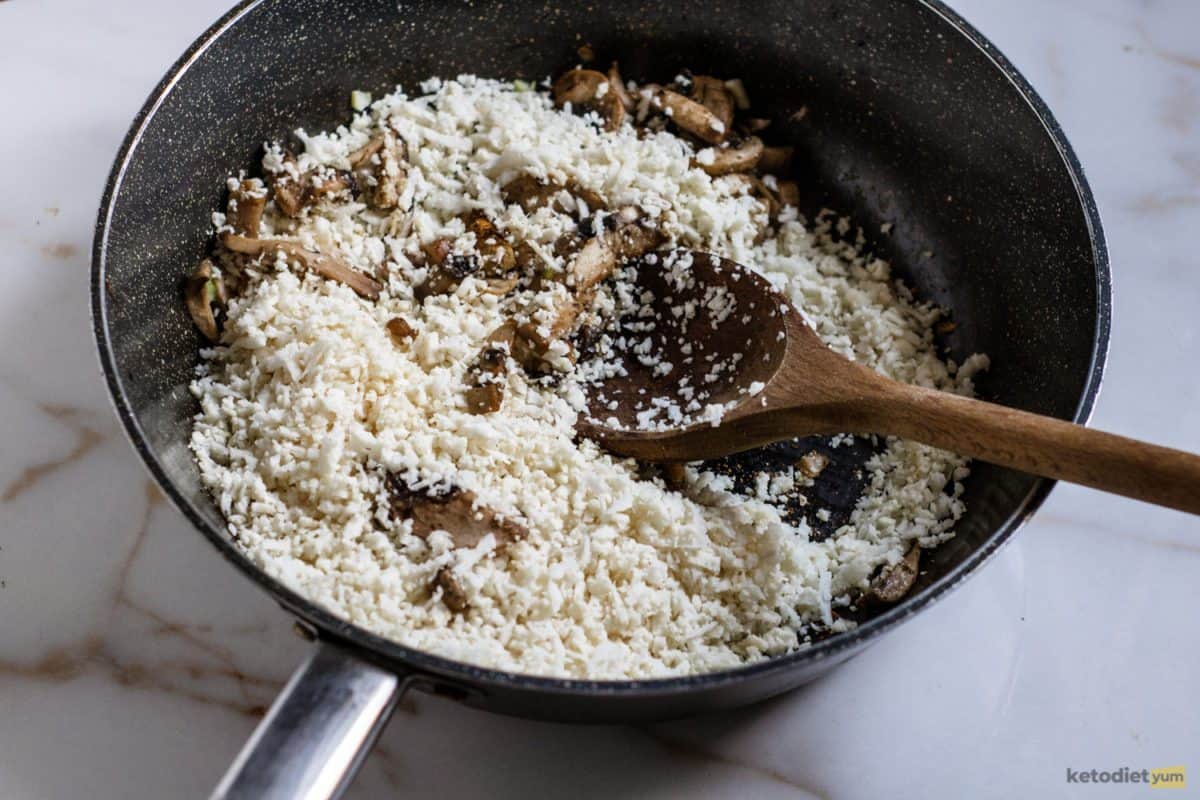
[95,0,1106,690]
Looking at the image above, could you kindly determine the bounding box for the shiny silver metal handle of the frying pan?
[212,642,407,800]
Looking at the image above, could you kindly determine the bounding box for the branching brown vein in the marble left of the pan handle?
[0,479,282,718]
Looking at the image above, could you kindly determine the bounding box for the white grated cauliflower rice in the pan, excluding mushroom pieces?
[191,76,986,679]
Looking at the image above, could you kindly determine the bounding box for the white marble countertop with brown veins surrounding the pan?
[0,0,1200,799]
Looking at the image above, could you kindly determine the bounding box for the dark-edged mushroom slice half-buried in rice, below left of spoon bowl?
[386,475,528,547]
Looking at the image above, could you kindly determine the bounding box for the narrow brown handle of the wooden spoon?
[863,381,1200,515]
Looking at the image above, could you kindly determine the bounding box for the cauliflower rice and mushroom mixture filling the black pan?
[187,65,986,679]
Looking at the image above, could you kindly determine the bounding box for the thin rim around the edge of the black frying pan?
[91,0,1112,697]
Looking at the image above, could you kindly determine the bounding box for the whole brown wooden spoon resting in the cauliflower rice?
[578,251,1200,513]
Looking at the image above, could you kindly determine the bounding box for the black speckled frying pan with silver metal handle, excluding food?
[91,0,1110,798]
